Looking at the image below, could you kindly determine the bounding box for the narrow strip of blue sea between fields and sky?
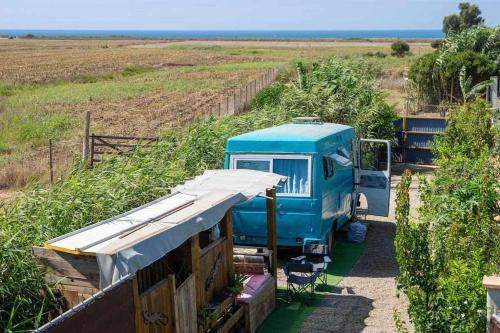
[0,29,444,39]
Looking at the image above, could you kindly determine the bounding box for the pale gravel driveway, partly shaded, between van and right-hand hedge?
[301,166,432,333]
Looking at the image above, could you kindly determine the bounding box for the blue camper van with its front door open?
[225,119,390,246]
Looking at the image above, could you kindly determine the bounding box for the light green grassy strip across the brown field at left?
[5,63,274,110]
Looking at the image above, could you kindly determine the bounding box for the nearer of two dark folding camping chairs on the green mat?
[283,262,319,302]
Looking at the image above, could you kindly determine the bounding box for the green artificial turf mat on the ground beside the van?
[258,241,365,333]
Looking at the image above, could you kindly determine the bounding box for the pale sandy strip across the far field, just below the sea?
[125,40,429,48]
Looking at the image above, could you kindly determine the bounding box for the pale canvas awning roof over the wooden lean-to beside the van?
[44,170,286,288]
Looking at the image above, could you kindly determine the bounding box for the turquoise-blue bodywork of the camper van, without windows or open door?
[224,123,354,246]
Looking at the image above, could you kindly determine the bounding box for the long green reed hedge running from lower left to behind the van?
[0,60,394,331]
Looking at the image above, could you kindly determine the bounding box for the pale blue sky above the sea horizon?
[0,0,500,30]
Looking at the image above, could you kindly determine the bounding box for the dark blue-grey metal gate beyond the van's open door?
[393,116,446,164]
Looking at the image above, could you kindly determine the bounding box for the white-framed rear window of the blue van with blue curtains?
[230,155,308,197]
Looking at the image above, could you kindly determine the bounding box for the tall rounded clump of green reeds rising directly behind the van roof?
[279,58,396,139]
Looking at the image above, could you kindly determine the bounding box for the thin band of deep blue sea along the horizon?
[0,29,443,41]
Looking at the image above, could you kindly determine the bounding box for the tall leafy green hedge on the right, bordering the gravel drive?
[395,100,500,333]
